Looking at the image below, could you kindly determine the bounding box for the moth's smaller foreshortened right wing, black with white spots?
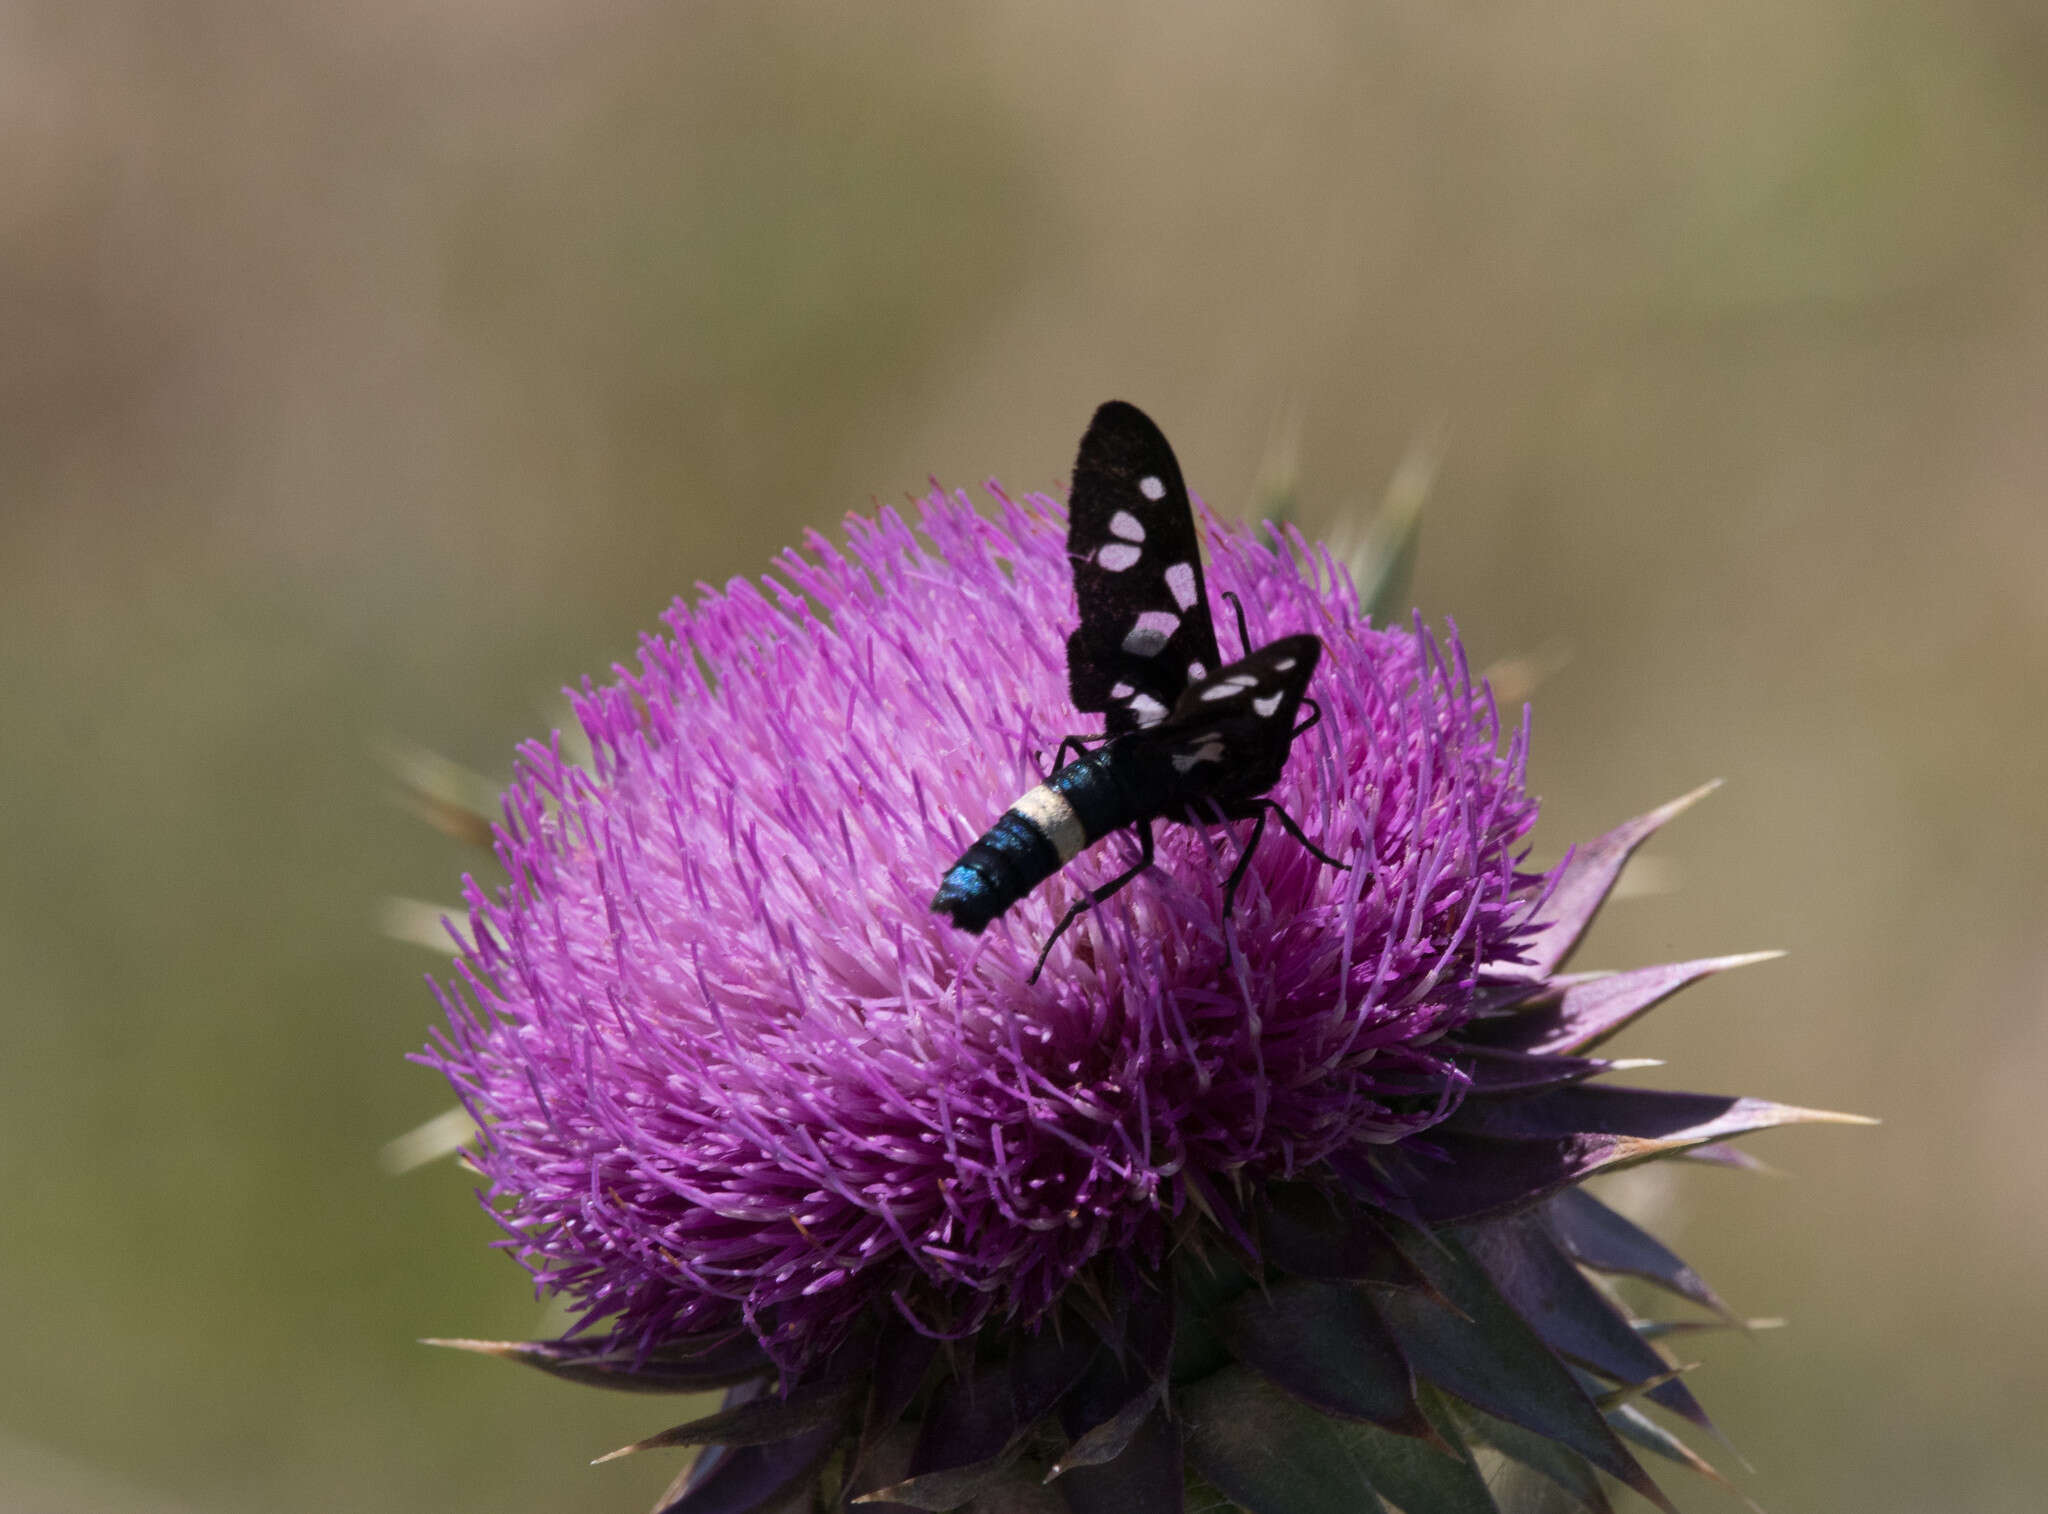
[1147,635,1323,805]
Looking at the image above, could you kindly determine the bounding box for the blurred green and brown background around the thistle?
[0,0,2048,1514]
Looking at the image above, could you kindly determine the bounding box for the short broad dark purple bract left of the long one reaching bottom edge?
[1219,1280,1436,1440]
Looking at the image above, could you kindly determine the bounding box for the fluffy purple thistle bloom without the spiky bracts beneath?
[432,494,1540,1366]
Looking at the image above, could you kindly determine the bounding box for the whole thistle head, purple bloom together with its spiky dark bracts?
[422,460,1867,1514]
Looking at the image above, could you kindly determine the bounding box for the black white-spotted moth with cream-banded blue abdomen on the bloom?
[932,399,1343,979]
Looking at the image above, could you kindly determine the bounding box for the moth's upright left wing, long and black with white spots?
[1067,399,1223,735]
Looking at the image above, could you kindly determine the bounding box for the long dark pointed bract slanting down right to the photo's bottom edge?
[1374,1225,1671,1514]
